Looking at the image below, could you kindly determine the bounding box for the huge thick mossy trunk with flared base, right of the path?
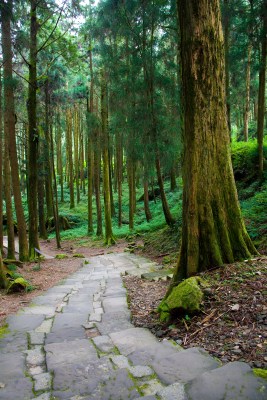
[174,0,257,284]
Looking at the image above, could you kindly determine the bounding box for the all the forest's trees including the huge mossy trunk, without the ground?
[0,0,267,286]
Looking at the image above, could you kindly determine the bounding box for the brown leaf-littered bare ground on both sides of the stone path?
[0,239,267,368]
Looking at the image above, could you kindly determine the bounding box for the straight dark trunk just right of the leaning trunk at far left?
[27,0,39,259]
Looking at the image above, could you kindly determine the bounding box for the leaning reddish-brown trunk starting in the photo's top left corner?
[1,0,28,261]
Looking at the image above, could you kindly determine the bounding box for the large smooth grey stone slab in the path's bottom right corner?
[186,361,267,400]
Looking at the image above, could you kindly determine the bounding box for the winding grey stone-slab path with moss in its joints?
[0,253,267,400]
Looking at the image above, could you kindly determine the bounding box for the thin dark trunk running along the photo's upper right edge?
[257,0,267,178]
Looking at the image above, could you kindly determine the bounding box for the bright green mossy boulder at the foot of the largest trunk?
[158,276,208,322]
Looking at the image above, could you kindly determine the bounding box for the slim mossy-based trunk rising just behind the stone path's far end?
[101,70,115,246]
